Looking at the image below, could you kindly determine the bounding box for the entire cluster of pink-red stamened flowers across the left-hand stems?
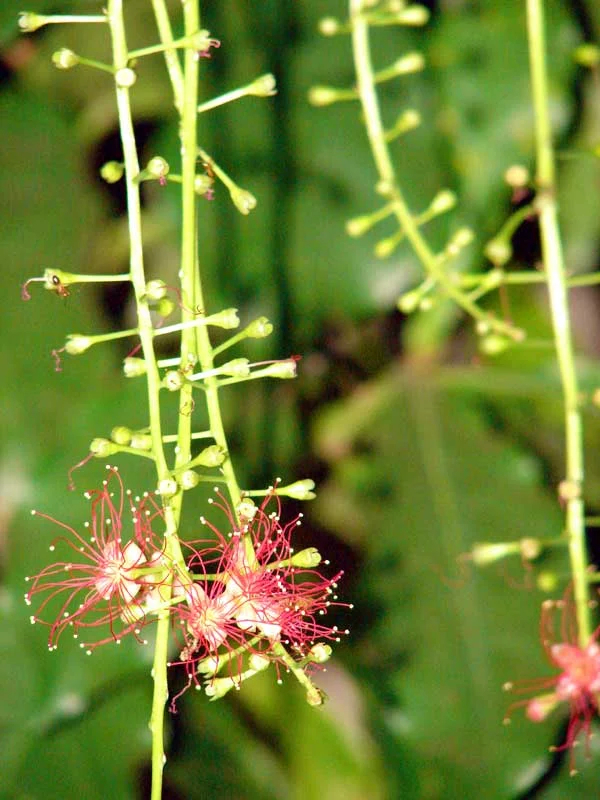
[25,467,347,708]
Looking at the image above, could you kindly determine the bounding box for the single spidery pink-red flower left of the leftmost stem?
[25,467,168,652]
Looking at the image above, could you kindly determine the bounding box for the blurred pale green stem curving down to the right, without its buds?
[350,0,522,340]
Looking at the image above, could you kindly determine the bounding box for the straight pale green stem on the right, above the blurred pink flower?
[527,0,591,647]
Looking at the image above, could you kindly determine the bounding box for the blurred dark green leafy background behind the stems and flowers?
[0,0,600,800]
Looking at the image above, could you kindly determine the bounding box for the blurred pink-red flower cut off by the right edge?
[504,590,600,775]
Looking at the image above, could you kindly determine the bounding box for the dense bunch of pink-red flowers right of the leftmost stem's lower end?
[173,482,348,696]
